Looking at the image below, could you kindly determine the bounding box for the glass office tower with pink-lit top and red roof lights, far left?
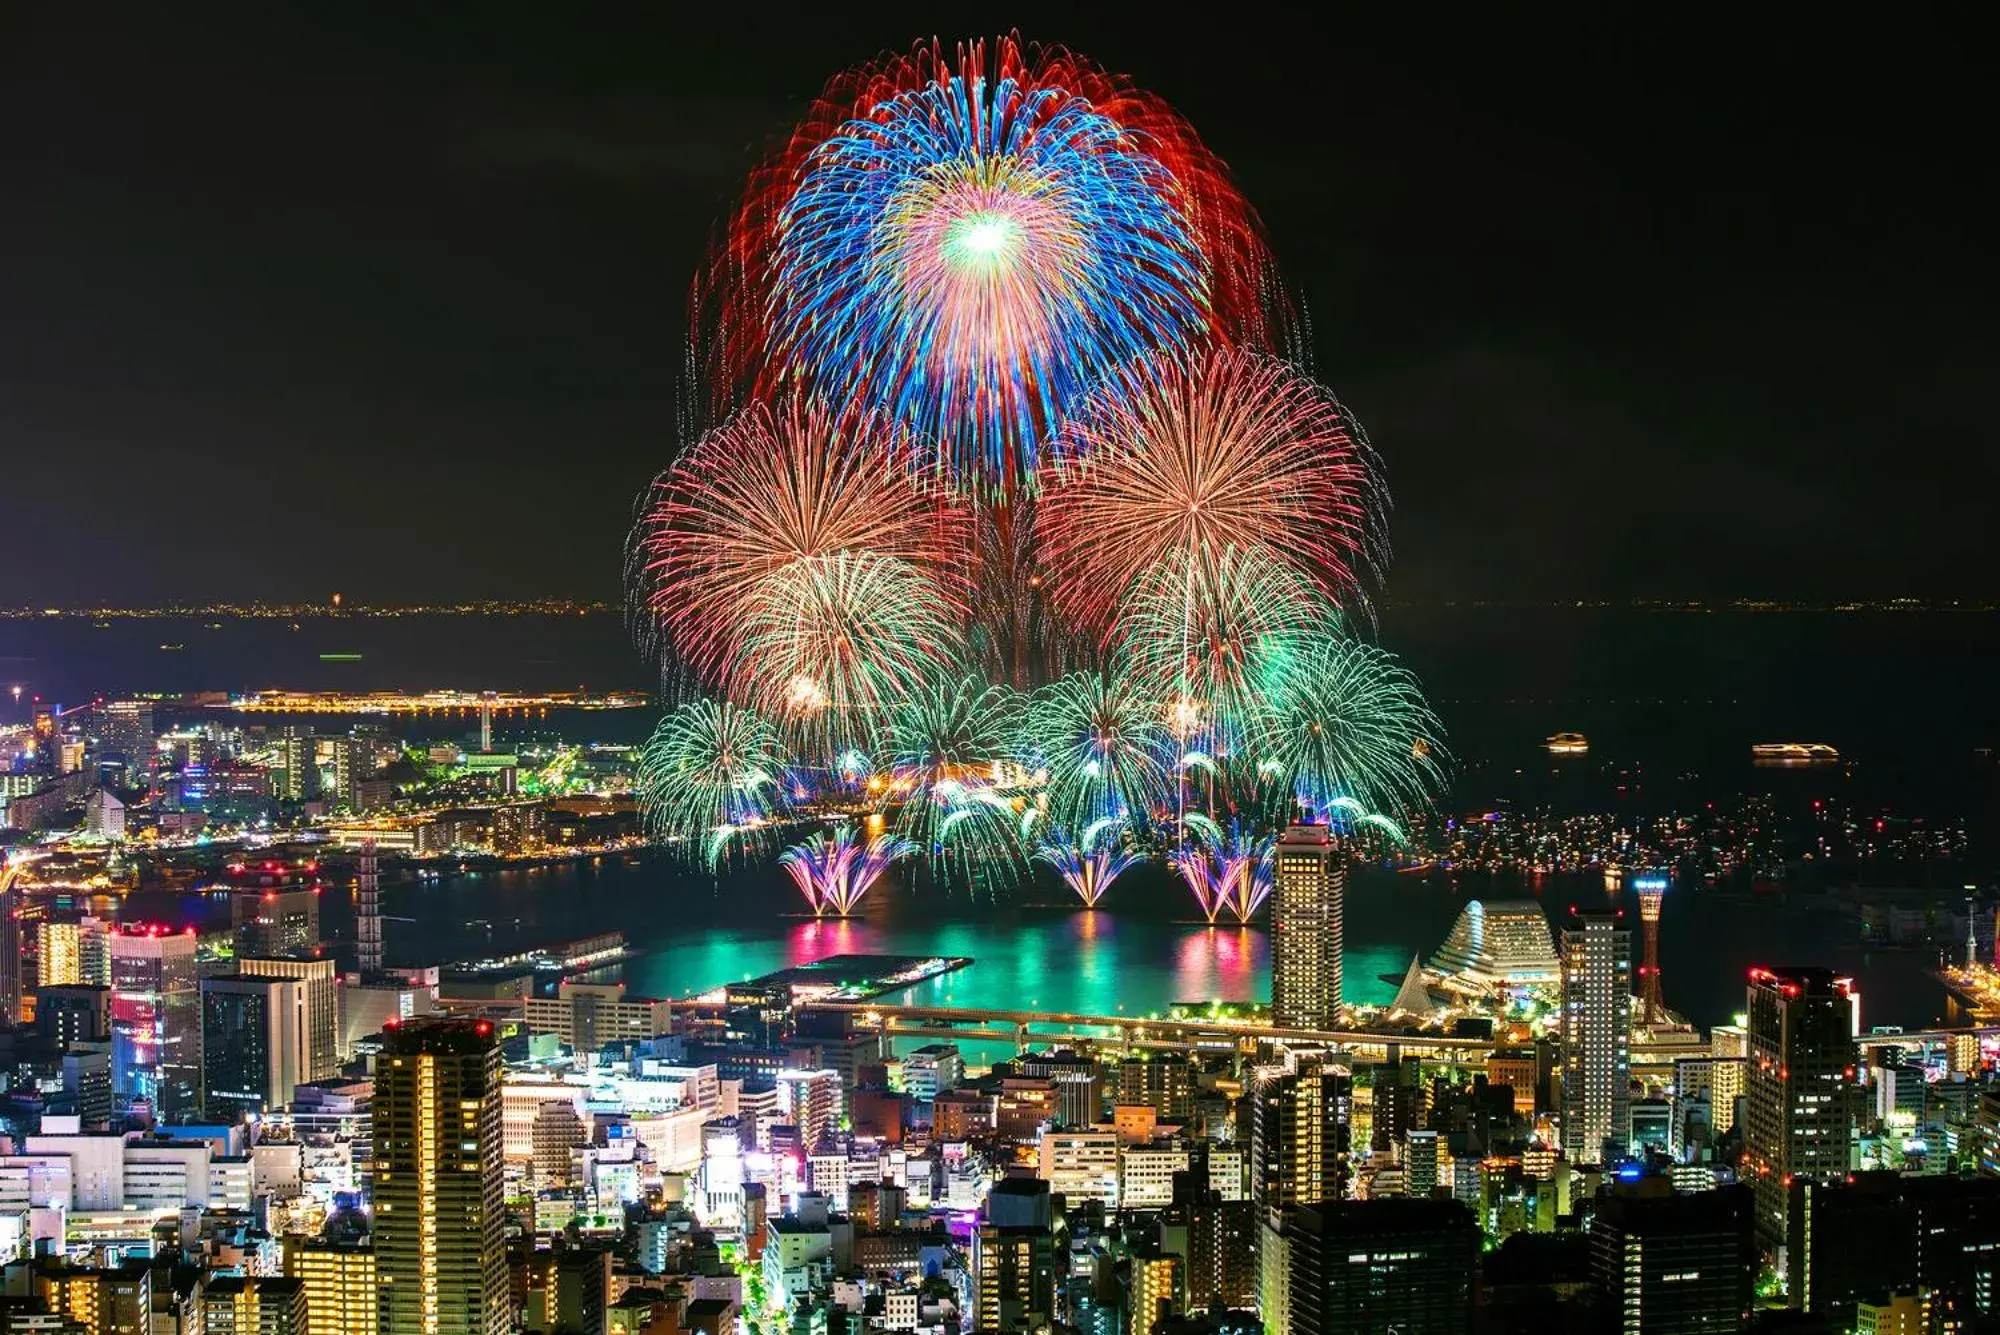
[110,927,202,1121]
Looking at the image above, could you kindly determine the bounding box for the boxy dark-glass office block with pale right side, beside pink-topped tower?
[202,973,312,1121]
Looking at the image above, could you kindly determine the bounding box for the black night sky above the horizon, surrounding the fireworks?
[0,2,2000,604]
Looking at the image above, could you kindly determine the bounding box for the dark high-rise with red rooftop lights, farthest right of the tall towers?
[1744,969,1860,1251]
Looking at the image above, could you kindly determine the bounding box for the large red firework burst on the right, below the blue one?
[1038,350,1384,632]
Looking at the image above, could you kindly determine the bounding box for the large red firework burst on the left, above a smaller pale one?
[636,400,966,699]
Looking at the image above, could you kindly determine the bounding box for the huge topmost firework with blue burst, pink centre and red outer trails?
[696,38,1286,492]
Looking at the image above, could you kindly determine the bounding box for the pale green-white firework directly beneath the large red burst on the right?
[1112,548,1332,751]
